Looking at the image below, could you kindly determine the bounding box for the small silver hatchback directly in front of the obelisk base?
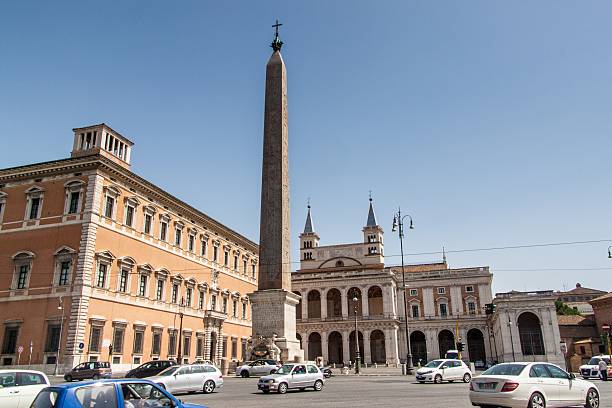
[257,363,325,394]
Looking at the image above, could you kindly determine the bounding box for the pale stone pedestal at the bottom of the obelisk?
[249,289,304,362]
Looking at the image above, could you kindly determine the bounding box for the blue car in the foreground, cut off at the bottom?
[30,378,206,408]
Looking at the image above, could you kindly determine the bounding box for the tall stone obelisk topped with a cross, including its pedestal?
[250,21,304,361]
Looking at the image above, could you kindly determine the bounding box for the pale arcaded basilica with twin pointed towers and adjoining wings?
[292,200,563,366]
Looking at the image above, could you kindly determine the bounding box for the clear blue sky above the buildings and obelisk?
[0,0,612,291]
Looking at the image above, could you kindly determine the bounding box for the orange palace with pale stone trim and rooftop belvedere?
[0,124,258,371]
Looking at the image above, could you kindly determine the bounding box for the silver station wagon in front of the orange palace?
[147,364,223,394]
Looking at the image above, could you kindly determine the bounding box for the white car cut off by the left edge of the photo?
[0,370,50,408]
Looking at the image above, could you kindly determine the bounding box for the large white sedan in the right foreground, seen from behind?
[470,363,599,408]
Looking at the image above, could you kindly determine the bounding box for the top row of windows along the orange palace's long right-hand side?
[103,187,256,279]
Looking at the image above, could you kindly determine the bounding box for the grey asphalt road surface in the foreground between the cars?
[177,376,612,408]
